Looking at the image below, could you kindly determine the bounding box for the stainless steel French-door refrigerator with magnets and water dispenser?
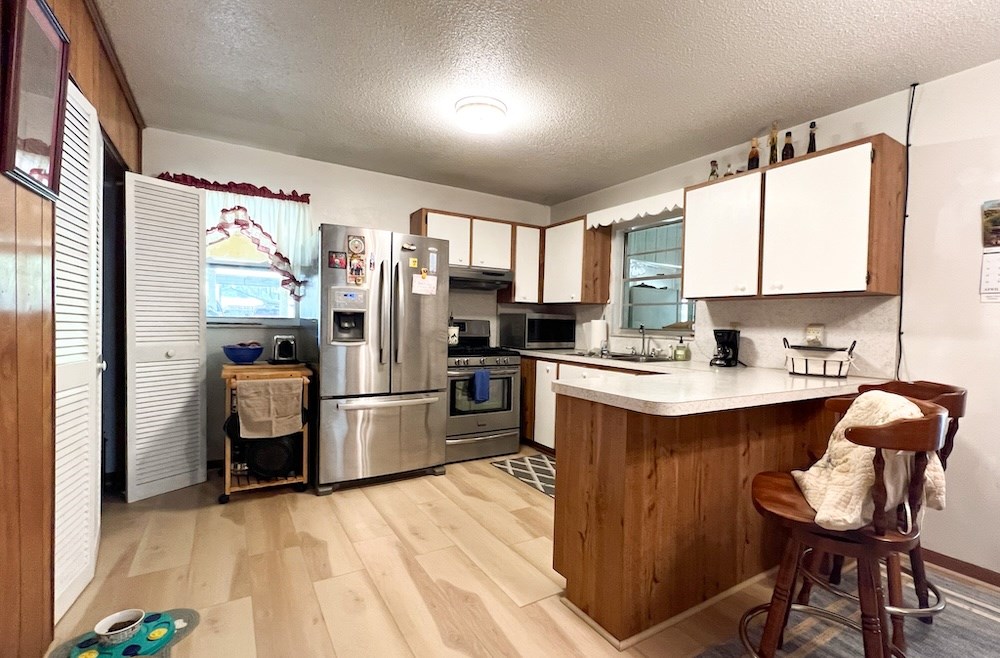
[301,224,448,494]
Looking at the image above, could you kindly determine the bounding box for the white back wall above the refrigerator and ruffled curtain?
[142,128,549,231]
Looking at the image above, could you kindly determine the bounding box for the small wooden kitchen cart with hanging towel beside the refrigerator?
[219,363,313,504]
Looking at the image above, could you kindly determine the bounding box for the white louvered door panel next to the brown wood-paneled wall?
[54,85,104,621]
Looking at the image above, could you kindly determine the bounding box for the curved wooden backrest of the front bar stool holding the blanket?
[826,396,948,535]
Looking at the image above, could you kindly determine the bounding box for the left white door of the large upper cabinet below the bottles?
[682,173,770,299]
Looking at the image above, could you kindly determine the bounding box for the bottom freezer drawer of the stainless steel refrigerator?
[317,391,447,485]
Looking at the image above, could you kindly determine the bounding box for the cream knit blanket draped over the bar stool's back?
[792,391,945,530]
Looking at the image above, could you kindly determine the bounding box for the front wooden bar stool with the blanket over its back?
[739,397,947,658]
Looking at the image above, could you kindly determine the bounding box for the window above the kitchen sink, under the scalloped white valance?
[620,217,695,335]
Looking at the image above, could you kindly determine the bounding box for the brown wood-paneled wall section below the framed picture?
[0,176,55,656]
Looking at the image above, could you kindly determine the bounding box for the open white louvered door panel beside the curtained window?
[125,173,205,502]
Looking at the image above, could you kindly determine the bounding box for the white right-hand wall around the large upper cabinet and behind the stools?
[552,61,1000,571]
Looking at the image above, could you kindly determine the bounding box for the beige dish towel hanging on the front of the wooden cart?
[236,377,302,439]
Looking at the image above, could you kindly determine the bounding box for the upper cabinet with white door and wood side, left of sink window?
[542,217,611,304]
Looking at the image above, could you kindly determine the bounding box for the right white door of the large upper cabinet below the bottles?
[761,143,872,295]
